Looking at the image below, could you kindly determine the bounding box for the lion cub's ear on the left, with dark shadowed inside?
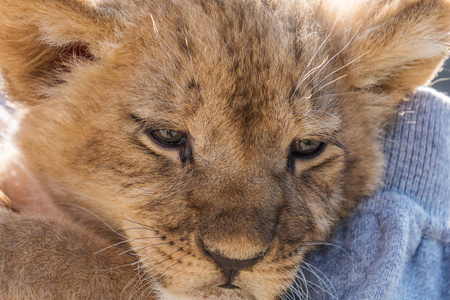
[0,0,120,104]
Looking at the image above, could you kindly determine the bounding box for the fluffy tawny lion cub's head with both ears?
[0,0,450,299]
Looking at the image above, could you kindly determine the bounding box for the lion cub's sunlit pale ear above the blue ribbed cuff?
[322,0,450,99]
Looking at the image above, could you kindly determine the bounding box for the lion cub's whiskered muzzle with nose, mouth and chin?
[119,195,320,300]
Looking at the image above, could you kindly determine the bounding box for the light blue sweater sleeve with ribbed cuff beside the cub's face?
[285,88,450,300]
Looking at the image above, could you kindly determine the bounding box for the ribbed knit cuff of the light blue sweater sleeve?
[383,88,450,224]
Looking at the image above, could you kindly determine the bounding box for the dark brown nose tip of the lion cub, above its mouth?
[205,249,262,289]
